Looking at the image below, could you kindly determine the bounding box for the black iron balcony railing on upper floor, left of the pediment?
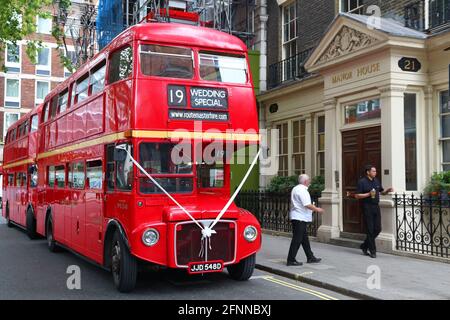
[268,48,313,89]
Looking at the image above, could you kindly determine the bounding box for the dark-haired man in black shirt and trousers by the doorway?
[355,166,394,258]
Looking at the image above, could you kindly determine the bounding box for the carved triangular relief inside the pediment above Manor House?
[316,25,379,64]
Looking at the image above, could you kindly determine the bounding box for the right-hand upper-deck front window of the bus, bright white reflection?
[200,53,247,84]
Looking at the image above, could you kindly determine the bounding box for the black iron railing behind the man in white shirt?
[236,191,321,236]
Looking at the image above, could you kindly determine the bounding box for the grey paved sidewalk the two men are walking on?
[256,234,450,300]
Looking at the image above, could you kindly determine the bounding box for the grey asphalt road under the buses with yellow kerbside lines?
[0,219,353,304]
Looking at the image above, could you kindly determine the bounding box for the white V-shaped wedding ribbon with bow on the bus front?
[116,144,261,261]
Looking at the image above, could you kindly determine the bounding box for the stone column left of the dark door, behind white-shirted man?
[317,99,340,242]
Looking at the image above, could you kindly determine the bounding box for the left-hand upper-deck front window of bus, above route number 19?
[140,44,194,79]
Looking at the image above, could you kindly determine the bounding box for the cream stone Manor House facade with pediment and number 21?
[258,0,450,255]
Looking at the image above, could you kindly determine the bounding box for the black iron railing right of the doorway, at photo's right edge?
[394,194,450,258]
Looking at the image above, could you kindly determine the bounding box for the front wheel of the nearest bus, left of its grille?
[111,231,137,293]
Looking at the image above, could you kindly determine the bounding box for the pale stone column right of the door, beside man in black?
[377,85,406,252]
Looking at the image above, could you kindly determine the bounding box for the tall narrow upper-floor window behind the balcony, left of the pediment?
[283,1,298,59]
